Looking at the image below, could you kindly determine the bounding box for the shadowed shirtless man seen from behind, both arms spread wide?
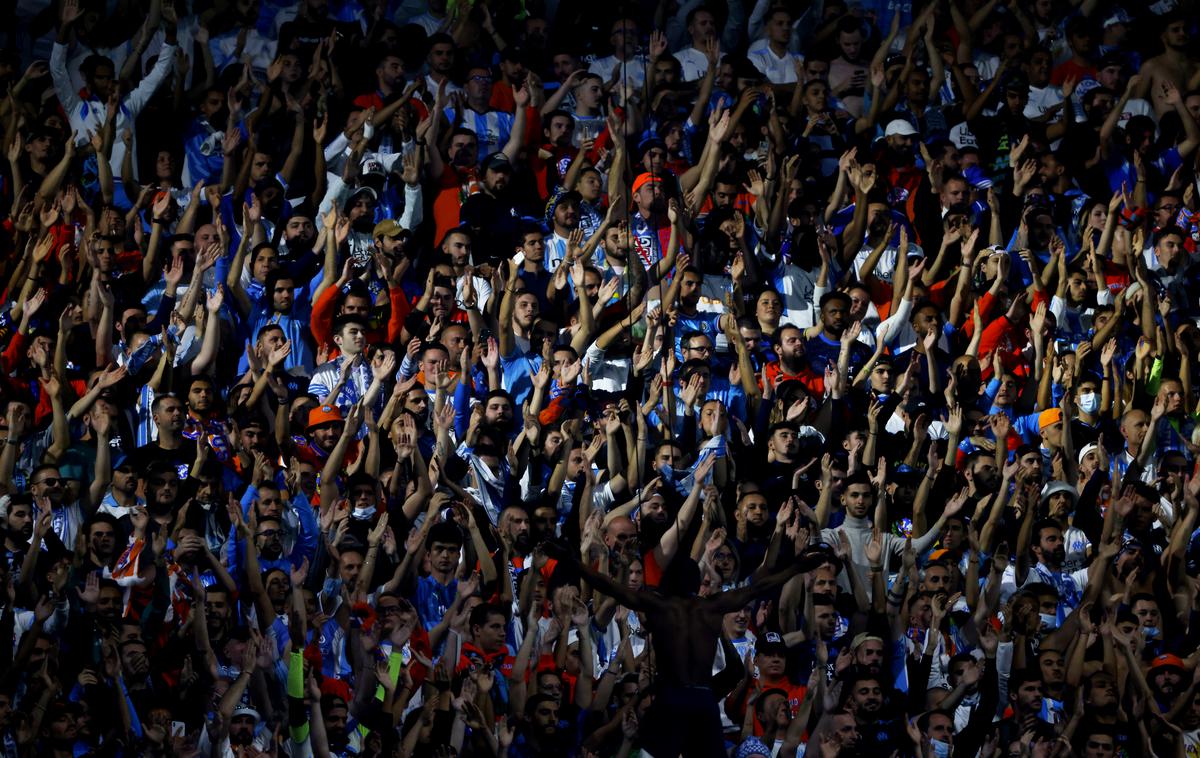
[568,542,828,758]
